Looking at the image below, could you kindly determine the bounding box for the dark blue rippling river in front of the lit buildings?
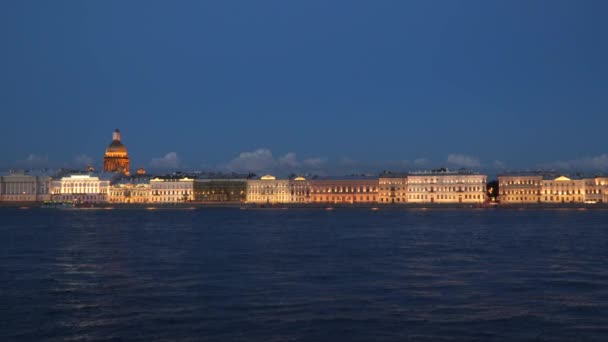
[0,208,608,341]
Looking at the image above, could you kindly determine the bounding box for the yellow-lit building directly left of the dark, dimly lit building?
[150,176,194,203]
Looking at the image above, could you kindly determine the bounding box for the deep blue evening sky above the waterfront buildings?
[0,0,608,174]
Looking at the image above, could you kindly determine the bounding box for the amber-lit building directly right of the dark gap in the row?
[498,173,543,204]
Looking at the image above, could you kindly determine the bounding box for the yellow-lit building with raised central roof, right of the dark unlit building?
[246,175,291,204]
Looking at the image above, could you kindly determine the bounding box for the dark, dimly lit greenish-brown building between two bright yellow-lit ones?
[194,179,247,203]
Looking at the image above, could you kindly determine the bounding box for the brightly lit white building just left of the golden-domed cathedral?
[51,174,110,203]
